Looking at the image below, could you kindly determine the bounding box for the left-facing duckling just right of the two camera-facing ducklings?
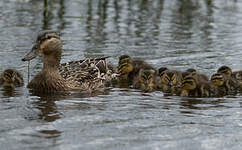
[180,75,218,97]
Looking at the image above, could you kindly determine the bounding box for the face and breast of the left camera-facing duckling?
[139,69,156,92]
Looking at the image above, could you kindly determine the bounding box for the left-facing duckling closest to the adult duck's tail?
[118,55,153,85]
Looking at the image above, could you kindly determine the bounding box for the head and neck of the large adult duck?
[22,30,62,68]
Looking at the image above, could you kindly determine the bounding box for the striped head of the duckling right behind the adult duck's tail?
[118,55,134,76]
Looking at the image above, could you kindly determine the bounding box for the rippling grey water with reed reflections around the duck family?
[0,0,242,150]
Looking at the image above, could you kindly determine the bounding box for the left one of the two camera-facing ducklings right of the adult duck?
[133,68,156,92]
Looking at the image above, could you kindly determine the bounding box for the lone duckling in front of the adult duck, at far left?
[0,69,24,88]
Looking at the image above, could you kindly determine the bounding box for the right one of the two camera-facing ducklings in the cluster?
[157,69,182,94]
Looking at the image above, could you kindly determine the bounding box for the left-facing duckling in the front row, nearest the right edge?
[210,73,239,96]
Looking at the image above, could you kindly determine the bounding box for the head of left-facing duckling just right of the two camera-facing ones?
[180,76,197,90]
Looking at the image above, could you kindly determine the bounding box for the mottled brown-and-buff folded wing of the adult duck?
[59,56,114,84]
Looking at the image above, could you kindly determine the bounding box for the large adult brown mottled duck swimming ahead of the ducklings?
[22,30,111,93]
